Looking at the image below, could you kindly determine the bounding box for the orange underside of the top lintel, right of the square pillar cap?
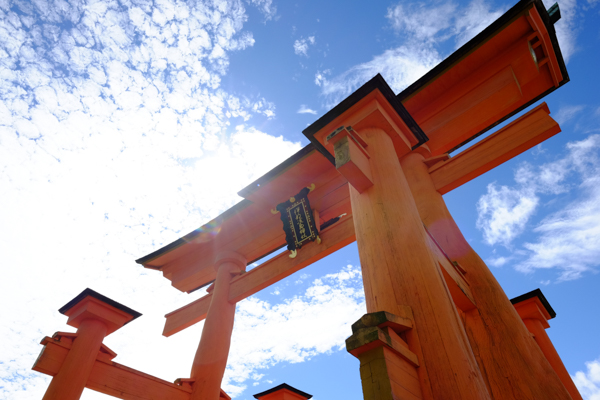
[403,4,563,156]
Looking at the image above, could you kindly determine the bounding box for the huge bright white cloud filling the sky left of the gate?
[0,0,300,400]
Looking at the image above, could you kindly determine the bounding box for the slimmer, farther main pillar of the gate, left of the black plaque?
[190,252,246,400]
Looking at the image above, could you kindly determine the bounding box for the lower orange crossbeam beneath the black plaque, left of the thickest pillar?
[163,215,355,336]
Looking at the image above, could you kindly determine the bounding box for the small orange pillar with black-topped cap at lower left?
[43,289,141,400]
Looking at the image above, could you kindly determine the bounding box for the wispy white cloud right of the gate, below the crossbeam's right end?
[478,135,600,280]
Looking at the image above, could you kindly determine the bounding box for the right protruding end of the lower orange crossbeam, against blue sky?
[429,103,560,194]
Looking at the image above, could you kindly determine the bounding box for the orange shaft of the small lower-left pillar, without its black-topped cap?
[43,318,108,400]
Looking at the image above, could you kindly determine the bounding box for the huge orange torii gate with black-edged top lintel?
[31,0,581,400]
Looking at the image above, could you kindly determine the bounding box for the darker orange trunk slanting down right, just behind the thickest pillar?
[402,153,571,400]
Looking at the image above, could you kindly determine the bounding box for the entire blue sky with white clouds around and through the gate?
[0,0,600,399]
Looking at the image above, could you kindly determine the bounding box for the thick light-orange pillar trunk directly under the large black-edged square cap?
[350,128,490,400]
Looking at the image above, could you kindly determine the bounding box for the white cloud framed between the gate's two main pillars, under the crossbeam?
[223,265,366,395]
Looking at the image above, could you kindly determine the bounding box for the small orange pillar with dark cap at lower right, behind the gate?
[510,289,582,400]
